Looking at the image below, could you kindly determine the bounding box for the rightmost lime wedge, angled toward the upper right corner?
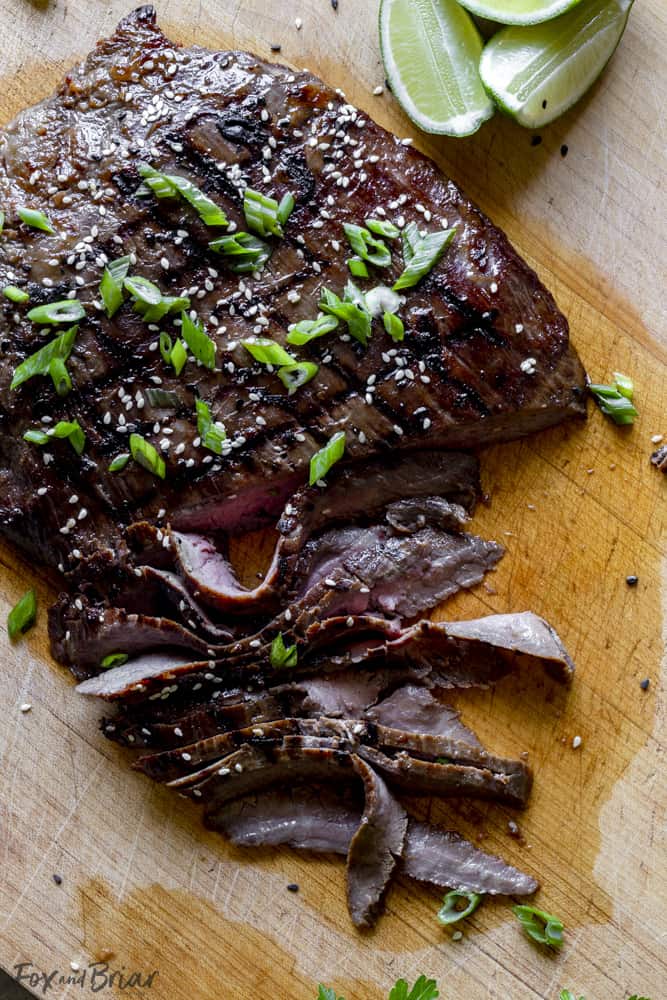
[479,0,633,128]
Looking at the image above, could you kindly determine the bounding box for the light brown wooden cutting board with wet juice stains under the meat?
[0,0,667,1000]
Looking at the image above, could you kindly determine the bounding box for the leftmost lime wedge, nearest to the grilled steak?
[380,0,494,136]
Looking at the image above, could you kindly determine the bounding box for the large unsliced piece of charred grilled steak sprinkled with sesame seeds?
[0,7,585,575]
